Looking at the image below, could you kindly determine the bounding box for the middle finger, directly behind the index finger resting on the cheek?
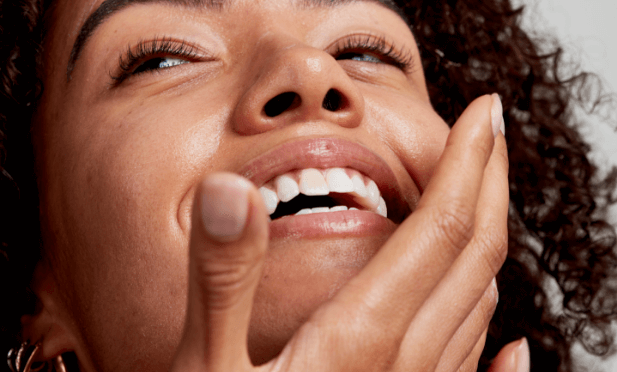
[398,128,509,370]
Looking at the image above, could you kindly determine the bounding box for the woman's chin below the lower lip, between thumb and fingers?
[248,231,396,365]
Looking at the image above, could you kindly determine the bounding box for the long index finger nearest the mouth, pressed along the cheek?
[288,96,494,370]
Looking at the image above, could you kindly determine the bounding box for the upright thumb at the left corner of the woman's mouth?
[173,173,268,371]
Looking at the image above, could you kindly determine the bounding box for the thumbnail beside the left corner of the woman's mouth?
[201,174,250,243]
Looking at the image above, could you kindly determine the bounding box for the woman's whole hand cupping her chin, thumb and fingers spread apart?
[172,96,518,372]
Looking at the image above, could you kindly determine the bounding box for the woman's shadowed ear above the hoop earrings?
[21,260,76,362]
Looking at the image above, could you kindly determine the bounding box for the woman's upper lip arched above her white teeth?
[239,138,411,223]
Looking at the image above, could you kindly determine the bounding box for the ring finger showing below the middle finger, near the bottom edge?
[436,281,499,372]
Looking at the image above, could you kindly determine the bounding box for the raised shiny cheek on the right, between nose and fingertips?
[367,95,450,191]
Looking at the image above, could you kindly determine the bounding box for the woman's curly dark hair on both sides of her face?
[0,0,617,372]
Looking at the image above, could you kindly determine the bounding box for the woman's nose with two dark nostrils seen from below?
[232,46,364,135]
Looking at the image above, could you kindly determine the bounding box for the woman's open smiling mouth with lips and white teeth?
[240,138,411,230]
